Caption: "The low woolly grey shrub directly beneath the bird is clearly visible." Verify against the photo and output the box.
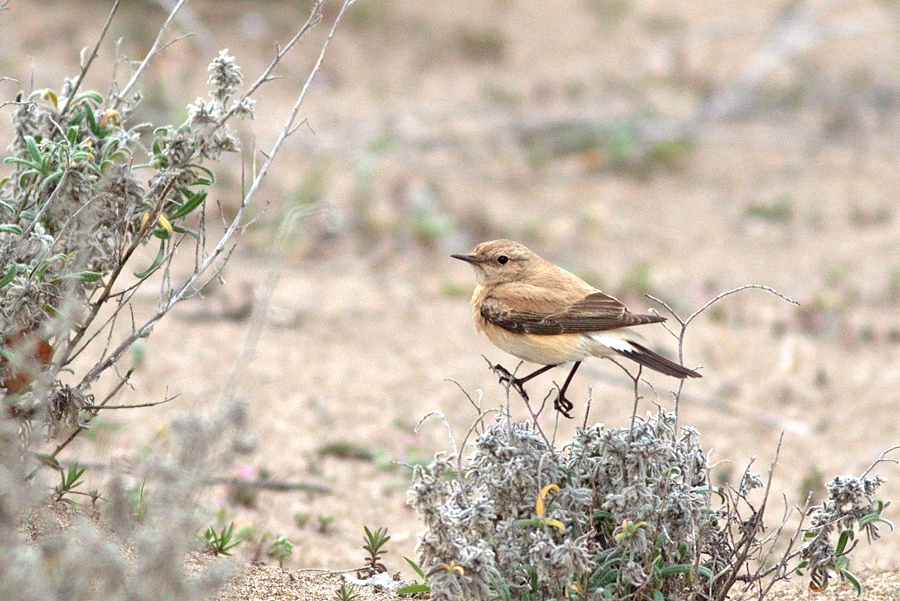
[410,290,893,601]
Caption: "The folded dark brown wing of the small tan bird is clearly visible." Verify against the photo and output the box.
[481,292,666,334]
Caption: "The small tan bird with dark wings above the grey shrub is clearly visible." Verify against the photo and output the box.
[451,240,701,417]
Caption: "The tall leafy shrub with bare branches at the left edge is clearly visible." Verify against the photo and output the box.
[0,0,350,601]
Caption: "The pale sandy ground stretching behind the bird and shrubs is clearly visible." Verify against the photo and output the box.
[0,0,900,598]
